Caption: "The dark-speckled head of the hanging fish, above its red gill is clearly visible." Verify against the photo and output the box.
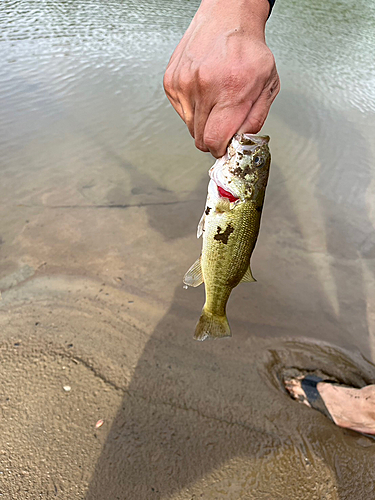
[210,134,271,202]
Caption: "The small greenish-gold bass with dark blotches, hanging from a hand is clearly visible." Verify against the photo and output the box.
[183,134,271,341]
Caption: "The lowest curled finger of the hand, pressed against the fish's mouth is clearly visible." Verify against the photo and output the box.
[203,102,251,158]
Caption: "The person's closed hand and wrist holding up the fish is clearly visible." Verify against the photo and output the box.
[164,0,280,158]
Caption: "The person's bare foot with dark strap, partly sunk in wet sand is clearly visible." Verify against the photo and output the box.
[284,375,375,435]
